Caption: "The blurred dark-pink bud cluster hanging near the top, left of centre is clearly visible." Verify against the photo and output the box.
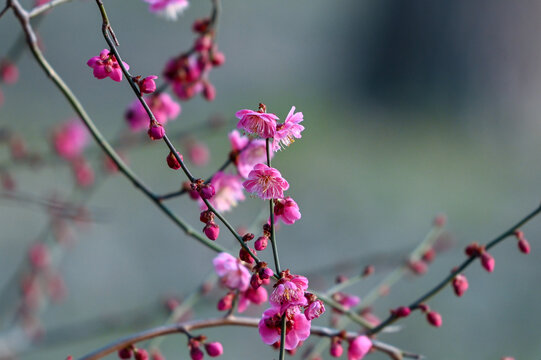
[163,18,225,101]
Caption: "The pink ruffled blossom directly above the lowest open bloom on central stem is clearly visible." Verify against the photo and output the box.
[270,270,308,313]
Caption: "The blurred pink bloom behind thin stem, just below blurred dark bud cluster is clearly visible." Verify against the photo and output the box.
[125,93,181,131]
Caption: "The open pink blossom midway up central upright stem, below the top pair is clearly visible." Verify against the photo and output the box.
[242,164,289,200]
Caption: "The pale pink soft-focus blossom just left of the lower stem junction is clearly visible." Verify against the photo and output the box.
[212,252,250,291]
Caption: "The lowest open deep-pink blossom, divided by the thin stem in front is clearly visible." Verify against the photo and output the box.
[258,306,311,350]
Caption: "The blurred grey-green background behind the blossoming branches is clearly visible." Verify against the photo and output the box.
[0,0,541,360]
